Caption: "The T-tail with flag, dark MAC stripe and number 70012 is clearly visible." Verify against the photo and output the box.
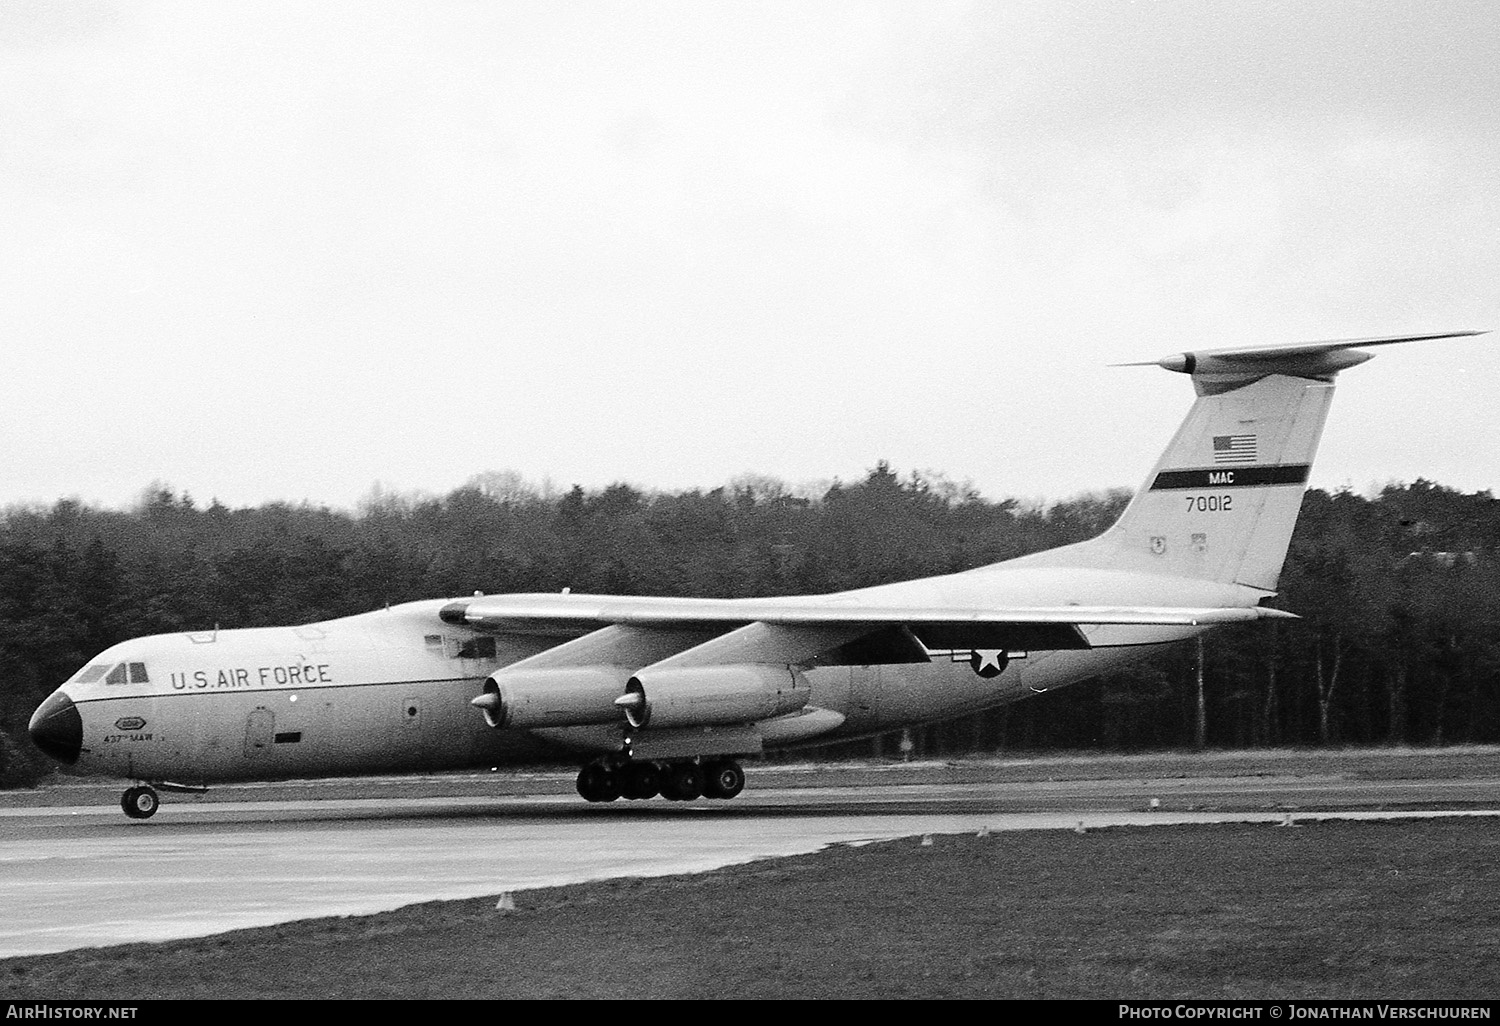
[1025,332,1484,593]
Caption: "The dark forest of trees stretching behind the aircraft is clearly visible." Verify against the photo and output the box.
[0,462,1500,786]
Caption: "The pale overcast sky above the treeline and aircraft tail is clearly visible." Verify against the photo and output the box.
[0,0,1500,509]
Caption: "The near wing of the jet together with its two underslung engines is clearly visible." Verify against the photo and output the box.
[441,594,1290,744]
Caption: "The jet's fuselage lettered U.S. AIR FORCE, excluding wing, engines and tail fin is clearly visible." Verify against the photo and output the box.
[32,561,1263,785]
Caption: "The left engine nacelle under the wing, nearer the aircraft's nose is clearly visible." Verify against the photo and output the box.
[473,666,630,728]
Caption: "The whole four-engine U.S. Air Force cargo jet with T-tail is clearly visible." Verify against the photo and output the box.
[30,332,1479,819]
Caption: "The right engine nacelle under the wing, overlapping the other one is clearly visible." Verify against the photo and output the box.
[617,663,812,728]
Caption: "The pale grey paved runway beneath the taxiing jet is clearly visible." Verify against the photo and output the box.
[0,753,1500,957]
